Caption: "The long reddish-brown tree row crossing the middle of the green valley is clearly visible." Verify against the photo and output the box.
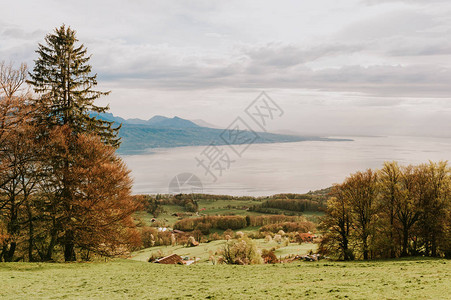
[174,215,305,234]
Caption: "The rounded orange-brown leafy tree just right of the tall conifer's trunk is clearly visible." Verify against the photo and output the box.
[63,134,138,256]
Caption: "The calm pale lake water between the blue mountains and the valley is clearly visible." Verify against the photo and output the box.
[123,137,451,196]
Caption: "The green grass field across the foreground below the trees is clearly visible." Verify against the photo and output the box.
[0,259,451,299]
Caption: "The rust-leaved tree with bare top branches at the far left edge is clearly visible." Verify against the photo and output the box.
[0,63,40,261]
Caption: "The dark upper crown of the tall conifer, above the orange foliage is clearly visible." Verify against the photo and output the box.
[28,25,120,147]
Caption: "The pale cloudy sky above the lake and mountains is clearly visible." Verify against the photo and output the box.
[0,0,451,137]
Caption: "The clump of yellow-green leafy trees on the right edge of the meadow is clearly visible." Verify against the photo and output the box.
[320,161,451,259]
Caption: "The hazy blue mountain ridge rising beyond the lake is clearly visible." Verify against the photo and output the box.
[88,113,354,154]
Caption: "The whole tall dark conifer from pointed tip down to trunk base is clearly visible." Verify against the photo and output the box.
[28,25,120,261]
